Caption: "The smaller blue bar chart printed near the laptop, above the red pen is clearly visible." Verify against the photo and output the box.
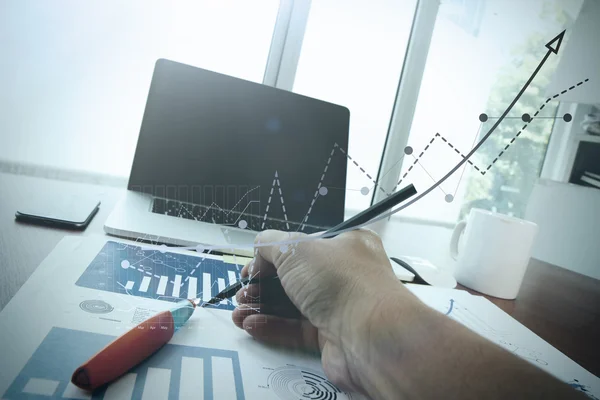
[76,241,240,310]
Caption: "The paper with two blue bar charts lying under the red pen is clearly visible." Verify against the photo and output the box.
[0,236,362,400]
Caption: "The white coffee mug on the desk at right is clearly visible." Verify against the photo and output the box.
[450,208,538,299]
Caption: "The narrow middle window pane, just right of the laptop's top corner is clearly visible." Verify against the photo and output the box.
[293,0,416,212]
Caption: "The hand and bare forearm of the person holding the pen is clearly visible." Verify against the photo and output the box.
[233,230,585,400]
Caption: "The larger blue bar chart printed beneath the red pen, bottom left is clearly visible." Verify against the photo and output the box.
[0,328,245,400]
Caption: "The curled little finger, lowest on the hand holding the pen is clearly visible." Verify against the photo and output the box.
[237,313,320,351]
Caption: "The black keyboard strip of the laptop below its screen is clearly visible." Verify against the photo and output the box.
[152,197,327,233]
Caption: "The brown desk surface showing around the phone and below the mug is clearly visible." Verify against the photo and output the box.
[0,173,600,376]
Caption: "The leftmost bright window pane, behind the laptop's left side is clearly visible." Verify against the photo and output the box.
[0,0,279,177]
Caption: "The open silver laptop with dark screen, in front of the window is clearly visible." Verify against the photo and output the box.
[104,59,350,254]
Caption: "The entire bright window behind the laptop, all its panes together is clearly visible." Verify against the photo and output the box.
[0,0,583,223]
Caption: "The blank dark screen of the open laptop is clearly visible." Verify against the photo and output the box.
[128,60,349,230]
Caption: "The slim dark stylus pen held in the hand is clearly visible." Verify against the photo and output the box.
[201,184,417,307]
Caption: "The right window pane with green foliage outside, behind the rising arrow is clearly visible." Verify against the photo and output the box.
[394,0,582,223]
